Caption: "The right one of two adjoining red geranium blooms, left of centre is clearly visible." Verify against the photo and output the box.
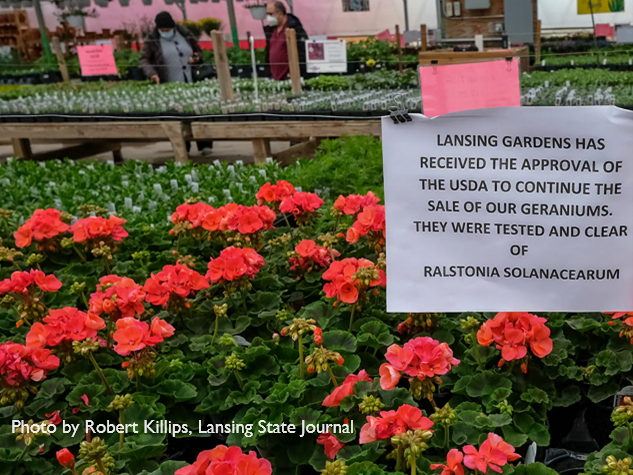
[143,264,209,307]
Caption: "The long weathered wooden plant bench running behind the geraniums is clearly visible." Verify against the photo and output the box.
[0,119,381,164]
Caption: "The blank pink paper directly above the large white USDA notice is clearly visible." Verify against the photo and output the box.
[420,59,521,117]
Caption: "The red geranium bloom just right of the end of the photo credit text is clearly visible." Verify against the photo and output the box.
[359,404,433,444]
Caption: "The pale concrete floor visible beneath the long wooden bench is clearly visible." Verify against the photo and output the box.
[0,141,290,165]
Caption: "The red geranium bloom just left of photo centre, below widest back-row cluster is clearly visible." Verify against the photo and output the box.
[206,246,264,283]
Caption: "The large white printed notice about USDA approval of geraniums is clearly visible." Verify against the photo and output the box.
[382,106,633,312]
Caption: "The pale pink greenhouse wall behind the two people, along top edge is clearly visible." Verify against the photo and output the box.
[19,0,437,38]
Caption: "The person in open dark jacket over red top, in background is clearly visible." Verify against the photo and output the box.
[264,1,308,81]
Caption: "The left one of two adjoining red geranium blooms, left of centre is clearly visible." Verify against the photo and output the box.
[89,275,146,320]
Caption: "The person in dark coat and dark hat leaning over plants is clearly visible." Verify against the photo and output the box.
[140,12,213,154]
